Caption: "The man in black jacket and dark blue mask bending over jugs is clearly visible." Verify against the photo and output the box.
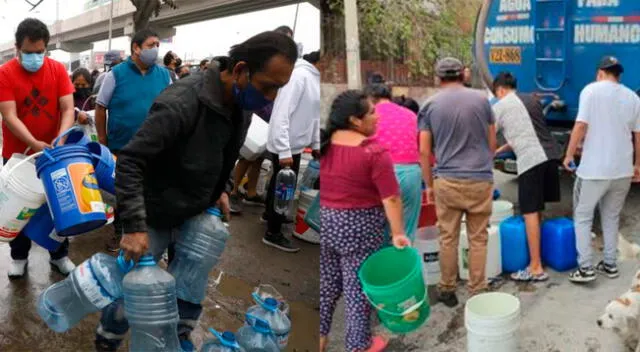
[95,32,298,351]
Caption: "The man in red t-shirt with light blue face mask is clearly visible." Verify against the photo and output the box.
[0,18,75,278]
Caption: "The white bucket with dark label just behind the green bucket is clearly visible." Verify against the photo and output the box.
[414,226,440,285]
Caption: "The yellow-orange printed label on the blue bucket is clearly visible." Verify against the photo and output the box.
[67,163,104,214]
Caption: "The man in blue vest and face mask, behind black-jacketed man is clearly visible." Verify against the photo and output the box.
[95,29,171,252]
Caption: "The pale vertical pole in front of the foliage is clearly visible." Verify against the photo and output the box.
[344,0,362,89]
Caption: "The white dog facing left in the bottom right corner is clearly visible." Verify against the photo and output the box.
[597,286,640,352]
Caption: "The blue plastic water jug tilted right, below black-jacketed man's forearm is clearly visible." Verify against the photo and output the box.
[168,208,229,304]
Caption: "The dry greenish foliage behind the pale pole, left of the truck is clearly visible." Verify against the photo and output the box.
[323,0,480,75]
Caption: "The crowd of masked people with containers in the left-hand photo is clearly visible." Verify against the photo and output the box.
[0,18,320,351]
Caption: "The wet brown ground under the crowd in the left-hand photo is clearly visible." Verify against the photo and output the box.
[0,199,319,352]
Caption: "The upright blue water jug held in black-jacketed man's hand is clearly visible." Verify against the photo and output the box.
[120,255,182,352]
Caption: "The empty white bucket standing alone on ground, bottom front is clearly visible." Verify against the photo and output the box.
[464,292,520,352]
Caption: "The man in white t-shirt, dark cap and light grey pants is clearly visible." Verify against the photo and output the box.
[563,56,640,283]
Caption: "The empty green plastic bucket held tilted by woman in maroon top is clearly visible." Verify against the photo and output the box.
[358,247,430,334]
